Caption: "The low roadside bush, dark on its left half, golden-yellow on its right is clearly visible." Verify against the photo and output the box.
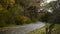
[15,16,31,25]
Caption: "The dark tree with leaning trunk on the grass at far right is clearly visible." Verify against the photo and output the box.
[41,1,60,34]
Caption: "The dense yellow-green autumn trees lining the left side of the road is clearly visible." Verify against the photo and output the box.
[0,0,39,27]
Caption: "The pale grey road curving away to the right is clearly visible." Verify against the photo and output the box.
[0,22,45,34]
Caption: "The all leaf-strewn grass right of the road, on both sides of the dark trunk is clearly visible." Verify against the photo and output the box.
[27,23,60,34]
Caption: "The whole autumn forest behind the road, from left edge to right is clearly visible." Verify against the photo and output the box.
[0,0,60,27]
